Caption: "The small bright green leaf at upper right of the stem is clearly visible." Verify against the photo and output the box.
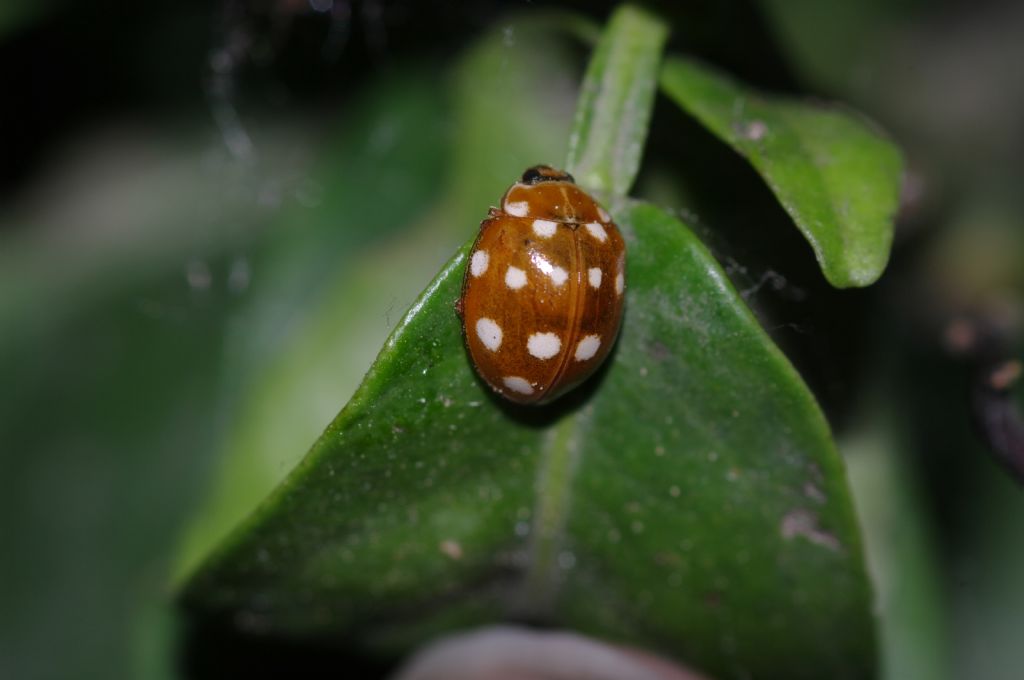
[660,57,902,288]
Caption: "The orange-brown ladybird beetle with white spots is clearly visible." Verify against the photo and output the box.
[456,165,626,403]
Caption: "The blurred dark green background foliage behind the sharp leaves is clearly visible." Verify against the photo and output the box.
[0,0,1024,679]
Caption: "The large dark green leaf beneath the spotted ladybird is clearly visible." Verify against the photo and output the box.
[184,204,874,678]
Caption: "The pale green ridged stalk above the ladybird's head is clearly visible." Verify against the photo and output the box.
[565,5,669,198]
